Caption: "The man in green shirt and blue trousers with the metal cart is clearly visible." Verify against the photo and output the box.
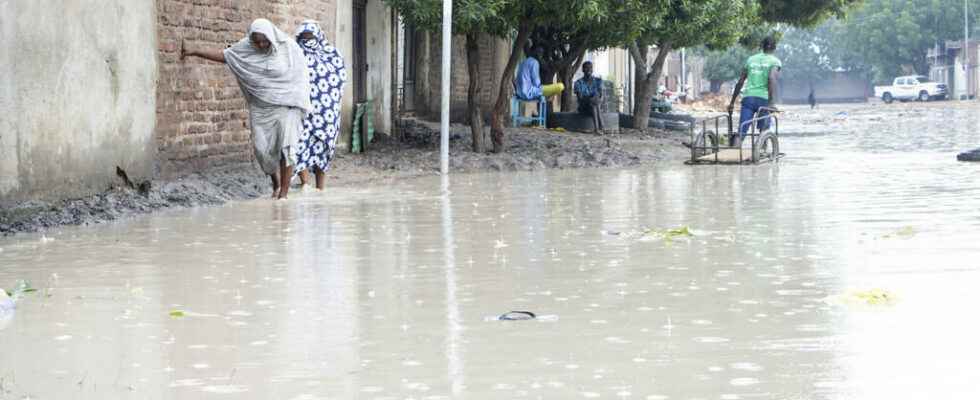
[728,37,783,143]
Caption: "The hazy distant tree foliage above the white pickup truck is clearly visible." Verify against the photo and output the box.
[838,0,980,82]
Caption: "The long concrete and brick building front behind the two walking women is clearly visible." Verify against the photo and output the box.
[0,0,399,202]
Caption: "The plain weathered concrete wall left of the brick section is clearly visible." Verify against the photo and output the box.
[0,0,157,205]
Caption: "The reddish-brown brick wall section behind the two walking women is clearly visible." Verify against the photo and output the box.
[156,0,337,175]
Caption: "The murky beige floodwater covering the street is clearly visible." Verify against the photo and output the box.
[0,103,980,400]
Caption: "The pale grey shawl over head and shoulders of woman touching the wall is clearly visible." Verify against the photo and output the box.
[225,19,313,113]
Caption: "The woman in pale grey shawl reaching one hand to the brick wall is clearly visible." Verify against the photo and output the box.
[181,19,313,199]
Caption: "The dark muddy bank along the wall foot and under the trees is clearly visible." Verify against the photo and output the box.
[0,120,687,236]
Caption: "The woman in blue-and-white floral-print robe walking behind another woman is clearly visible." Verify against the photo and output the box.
[296,21,347,190]
